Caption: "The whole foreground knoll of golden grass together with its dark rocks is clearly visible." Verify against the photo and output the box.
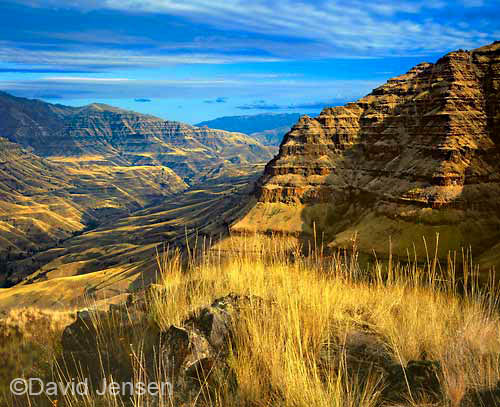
[0,236,500,407]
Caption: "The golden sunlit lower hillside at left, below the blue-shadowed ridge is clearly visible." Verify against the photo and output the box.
[0,138,187,281]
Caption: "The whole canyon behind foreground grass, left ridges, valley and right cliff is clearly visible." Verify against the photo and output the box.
[0,43,500,308]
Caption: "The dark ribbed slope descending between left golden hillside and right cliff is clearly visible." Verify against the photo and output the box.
[0,165,263,309]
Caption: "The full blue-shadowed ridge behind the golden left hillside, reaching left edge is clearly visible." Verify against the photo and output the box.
[0,92,275,183]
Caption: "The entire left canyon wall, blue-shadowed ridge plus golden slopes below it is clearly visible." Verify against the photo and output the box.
[0,92,276,272]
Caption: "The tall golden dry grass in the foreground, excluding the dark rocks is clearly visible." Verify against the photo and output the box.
[0,236,500,407]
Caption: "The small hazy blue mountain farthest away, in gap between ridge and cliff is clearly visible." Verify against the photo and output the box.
[196,113,310,146]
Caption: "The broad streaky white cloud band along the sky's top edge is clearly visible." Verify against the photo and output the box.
[10,0,491,55]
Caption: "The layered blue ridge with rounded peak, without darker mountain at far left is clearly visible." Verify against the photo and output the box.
[45,104,272,175]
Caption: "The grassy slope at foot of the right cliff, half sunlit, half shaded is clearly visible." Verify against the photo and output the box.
[231,202,500,278]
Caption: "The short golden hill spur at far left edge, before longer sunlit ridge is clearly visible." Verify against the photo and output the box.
[0,137,78,284]
